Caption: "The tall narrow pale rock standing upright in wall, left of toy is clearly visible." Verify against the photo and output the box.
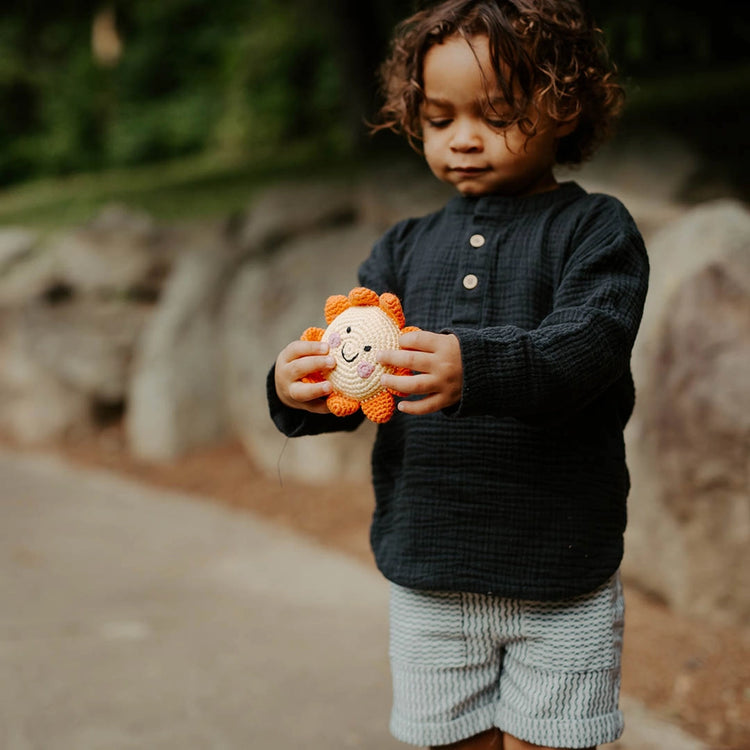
[126,232,238,461]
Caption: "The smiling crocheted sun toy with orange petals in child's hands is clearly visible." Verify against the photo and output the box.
[301,287,419,424]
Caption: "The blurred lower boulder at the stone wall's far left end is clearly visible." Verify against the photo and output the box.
[0,296,150,444]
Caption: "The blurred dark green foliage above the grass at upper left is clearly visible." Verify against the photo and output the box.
[0,0,362,184]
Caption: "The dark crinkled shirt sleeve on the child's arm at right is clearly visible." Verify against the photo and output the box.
[447,217,648,422]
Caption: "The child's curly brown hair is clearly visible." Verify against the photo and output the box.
[372,0,624,165]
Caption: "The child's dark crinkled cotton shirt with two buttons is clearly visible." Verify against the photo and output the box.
[269,182,648,600]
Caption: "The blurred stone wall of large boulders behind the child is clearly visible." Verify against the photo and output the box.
[0,144,750,624]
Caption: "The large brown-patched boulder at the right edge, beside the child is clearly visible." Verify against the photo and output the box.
[623,201,750,624]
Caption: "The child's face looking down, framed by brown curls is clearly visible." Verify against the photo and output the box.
[421,36,575,196]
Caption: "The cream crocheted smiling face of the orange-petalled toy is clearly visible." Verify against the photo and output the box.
[322,306,399,401]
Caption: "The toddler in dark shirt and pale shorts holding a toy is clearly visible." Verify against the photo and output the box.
[268,0,648,750]
